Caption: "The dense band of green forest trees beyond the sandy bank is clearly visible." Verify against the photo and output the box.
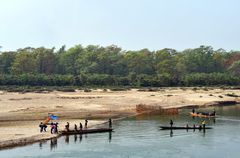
[0,45,240,87]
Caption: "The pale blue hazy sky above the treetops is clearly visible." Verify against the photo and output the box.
[0,0,240,51]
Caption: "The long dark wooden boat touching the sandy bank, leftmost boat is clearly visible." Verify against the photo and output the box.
[60,128,113,135]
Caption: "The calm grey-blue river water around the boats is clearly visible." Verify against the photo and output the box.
[0,105,240,158]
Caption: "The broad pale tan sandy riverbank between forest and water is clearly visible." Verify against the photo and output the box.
[0,88,240,148]
